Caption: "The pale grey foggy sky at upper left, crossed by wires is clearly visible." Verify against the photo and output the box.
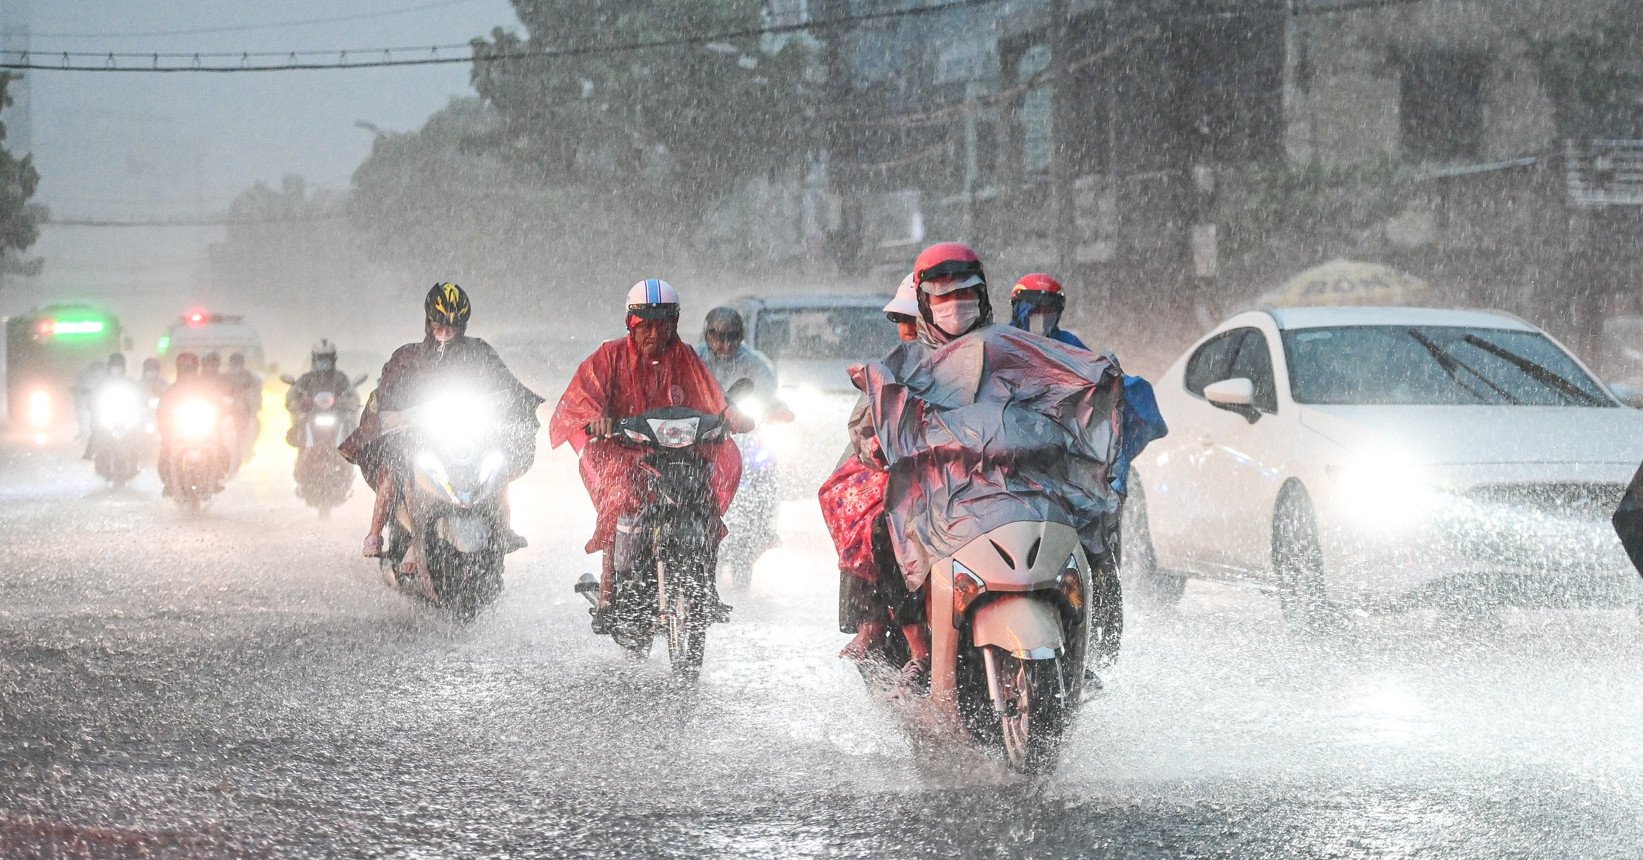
[0,0,518,333]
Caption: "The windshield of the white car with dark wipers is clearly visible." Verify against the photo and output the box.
[1283,326,1615,406]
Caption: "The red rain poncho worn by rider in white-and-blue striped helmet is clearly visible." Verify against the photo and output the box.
[547,337,741,553]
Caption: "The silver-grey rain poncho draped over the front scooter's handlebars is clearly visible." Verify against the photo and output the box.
[851,326,1124,589]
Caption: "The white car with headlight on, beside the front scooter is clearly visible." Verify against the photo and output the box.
[1124,307,1643,630]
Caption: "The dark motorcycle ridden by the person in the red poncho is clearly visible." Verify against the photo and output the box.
[577,380,751,681]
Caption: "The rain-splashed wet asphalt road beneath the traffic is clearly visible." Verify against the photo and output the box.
[0,444,1643,858]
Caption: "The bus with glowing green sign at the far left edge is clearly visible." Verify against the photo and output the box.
[5,304,123,434]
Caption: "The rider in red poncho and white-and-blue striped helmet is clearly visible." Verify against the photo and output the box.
[547,278,751,618]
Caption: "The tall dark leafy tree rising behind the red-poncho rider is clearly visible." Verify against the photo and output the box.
[473,0,808,250]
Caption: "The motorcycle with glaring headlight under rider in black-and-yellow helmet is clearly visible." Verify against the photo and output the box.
[381,393,508,622]
